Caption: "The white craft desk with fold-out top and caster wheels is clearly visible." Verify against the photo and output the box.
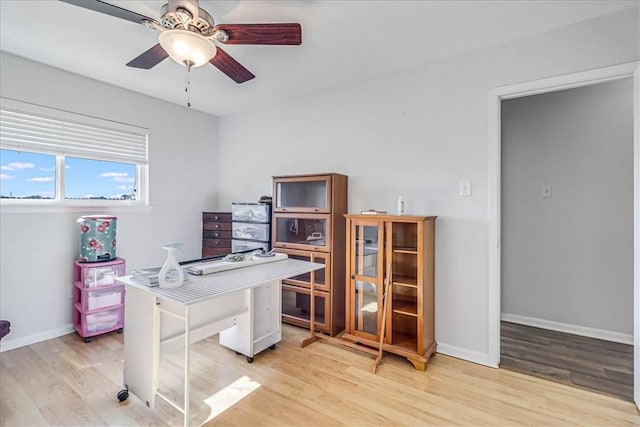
[117,259,324,426]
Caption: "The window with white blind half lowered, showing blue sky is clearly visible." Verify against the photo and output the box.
[0,98,148,206]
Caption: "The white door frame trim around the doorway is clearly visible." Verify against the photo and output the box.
[487,61,640,408]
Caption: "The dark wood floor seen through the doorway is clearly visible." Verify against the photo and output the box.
[500,322,633,401]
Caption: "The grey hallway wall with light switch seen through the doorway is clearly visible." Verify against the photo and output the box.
[501,78,633,341]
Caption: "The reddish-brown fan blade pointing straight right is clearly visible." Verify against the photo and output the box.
[213,24,302,45]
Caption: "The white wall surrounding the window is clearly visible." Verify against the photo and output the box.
[0,52,218,350]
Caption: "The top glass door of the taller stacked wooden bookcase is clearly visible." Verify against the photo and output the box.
[273,175,331,213]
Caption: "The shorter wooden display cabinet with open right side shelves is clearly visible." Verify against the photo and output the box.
[343,215,436,370]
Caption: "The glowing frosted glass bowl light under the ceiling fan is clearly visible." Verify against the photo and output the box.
[159,30,216,68]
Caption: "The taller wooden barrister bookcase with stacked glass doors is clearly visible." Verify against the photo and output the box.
[272,173,347,336]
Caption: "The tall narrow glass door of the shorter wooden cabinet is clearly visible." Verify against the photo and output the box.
[348,220,384,339]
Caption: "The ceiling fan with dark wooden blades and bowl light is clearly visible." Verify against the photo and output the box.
[61,0,302,83]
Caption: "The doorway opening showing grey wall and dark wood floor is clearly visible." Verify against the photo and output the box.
[500,78,633,401]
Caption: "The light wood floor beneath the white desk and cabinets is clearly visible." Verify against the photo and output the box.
[0,325,640,427]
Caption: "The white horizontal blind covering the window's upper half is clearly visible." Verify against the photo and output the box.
[0,98,148,165]
